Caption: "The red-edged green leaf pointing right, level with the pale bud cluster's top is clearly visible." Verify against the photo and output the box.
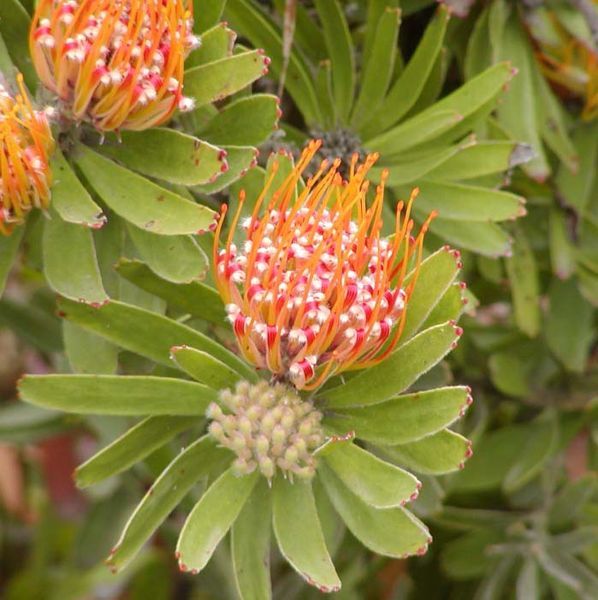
[328,386,471,446]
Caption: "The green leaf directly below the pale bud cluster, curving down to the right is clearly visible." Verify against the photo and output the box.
[272,475,341,592]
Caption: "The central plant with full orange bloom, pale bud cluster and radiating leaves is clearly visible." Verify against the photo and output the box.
[20,142,471,598]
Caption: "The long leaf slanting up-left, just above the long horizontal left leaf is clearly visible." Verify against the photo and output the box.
[59,300,253,377]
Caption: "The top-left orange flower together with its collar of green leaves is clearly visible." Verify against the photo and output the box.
[0,0,279,318]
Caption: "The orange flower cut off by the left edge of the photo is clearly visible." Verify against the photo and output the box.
[0,75,54,235]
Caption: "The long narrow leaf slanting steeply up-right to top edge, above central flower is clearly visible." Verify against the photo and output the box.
[362,7,449,139]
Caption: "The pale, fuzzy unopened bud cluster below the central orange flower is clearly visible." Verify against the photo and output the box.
[207,381,324,479]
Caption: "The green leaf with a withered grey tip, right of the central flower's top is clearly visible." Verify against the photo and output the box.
[426,141,533,181]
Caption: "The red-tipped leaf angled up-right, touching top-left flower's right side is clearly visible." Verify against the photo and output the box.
[185,50,269,106]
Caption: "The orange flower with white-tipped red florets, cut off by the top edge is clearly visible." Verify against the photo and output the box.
[29,0,199,131]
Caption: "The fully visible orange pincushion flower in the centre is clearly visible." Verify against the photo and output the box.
[214,141,434,389]
